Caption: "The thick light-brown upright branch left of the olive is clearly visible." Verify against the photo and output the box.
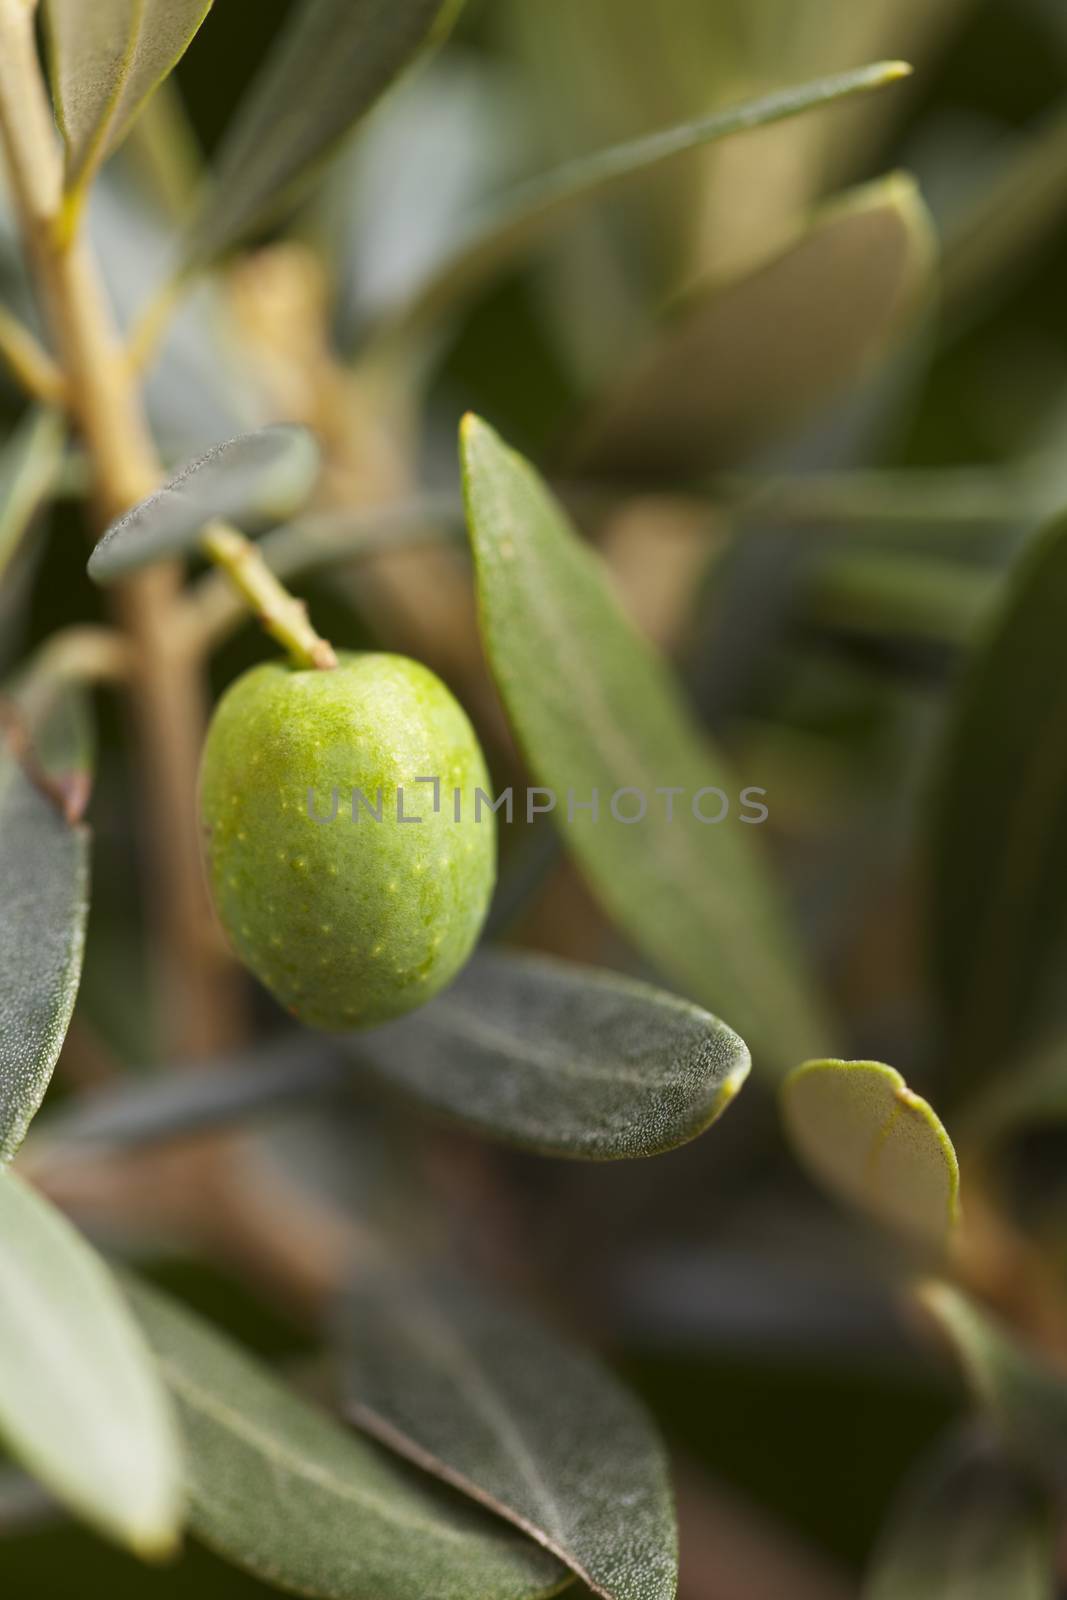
[0,0,230,1054]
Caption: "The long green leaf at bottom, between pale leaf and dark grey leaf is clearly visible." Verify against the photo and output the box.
[130,1285,563,1600]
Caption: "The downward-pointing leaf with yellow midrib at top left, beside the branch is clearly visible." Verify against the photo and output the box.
[45,0,211,209]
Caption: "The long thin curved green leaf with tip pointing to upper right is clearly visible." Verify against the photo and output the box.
[379,61,912,336]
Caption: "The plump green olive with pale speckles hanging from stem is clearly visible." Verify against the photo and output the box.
[200,654,496,1032]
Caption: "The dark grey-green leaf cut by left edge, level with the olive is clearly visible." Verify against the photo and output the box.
[0,723,90,1162]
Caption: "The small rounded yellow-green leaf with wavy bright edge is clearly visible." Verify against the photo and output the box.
[782,1061,960,1245]
